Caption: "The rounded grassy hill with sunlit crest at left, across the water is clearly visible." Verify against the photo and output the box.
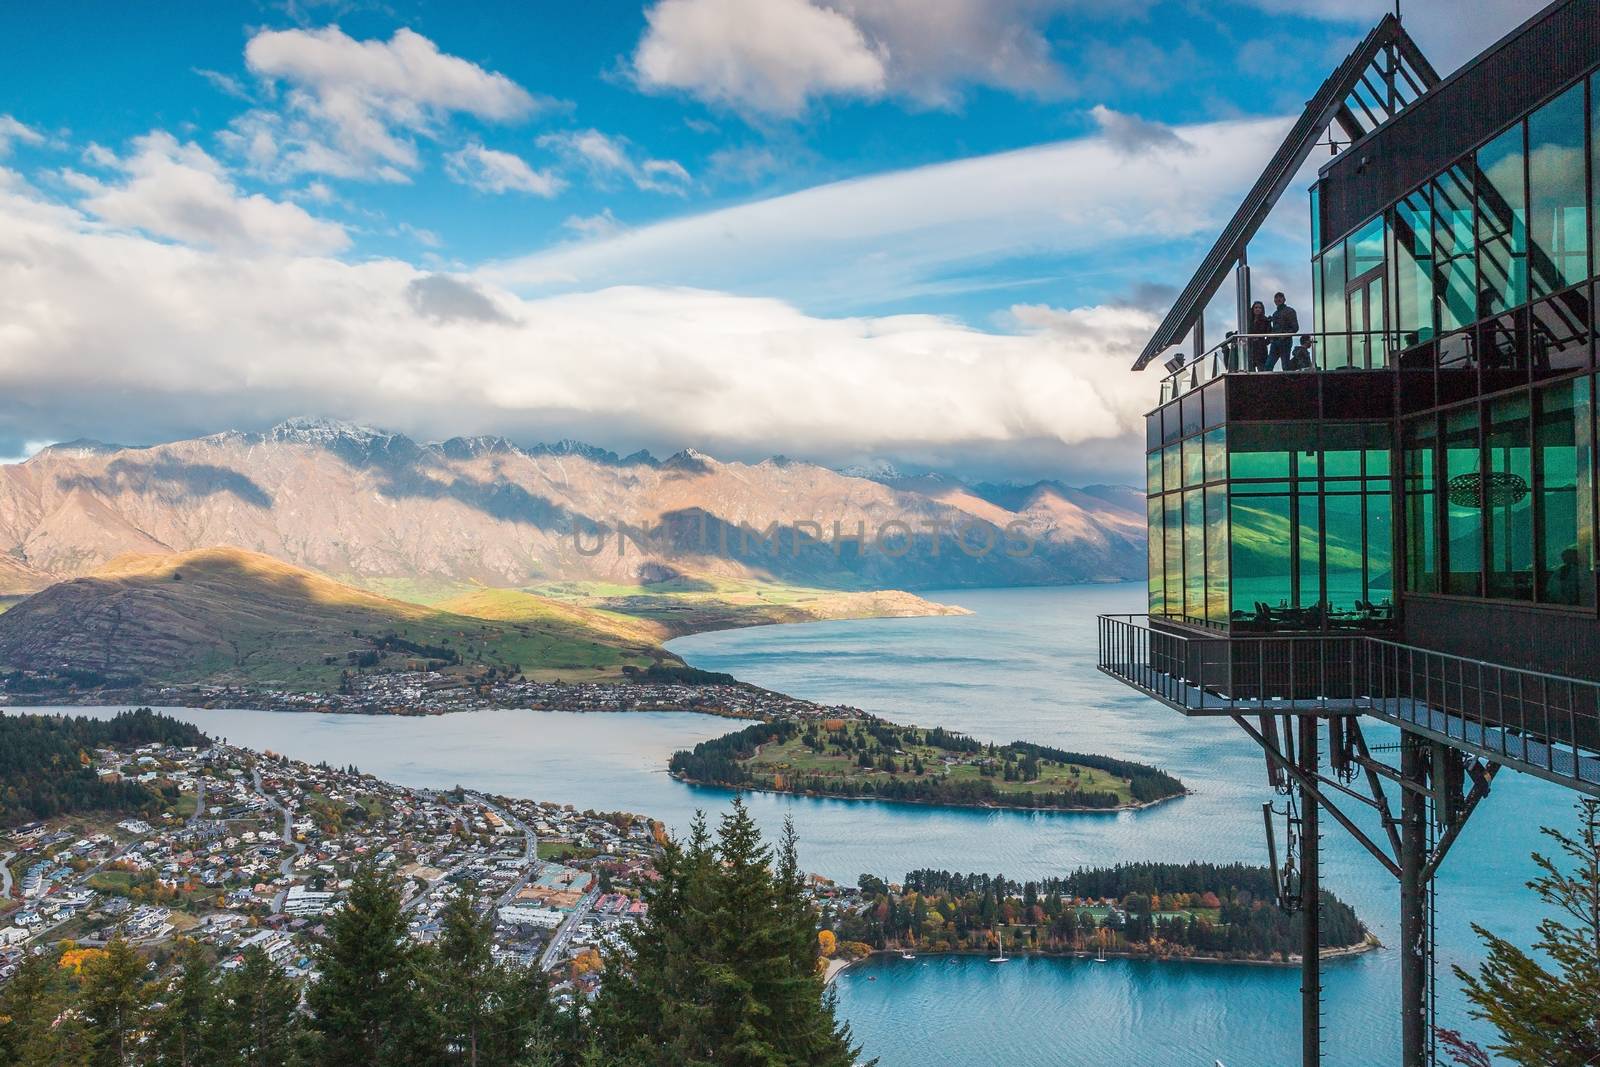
[0,549,678,689]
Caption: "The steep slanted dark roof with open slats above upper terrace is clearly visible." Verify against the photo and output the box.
[1133,14,1438,371]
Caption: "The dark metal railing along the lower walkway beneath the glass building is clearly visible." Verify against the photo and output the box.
[1099,614,1600,797]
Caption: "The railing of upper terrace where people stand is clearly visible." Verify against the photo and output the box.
[1162,330,1400,403]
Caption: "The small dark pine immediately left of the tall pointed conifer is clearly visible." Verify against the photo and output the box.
[203,947,299,1067]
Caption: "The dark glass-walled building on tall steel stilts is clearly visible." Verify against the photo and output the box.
[1099,0,1600,1067]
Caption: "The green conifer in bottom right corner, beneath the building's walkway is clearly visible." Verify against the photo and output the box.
[1451,800,1600,1067]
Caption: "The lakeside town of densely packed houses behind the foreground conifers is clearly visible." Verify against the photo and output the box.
[0,744,664,1000]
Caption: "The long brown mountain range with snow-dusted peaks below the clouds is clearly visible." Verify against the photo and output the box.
[0,418,1144,601]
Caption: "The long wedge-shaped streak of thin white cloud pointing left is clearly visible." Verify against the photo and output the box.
[485,118,1304,310]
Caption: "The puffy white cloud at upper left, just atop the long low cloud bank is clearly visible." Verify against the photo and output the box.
[64,131,350,253]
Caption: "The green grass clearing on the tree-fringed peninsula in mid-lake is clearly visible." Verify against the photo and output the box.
[749,723,1133,805]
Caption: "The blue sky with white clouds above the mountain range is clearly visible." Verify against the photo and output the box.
[0,0,1536,477]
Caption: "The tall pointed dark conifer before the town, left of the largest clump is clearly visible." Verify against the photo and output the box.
[306,861,440,1067]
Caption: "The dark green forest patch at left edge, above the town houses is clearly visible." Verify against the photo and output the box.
[0,707,206,825]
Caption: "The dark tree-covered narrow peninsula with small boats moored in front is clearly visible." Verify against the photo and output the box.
[834,862,1366,960]
